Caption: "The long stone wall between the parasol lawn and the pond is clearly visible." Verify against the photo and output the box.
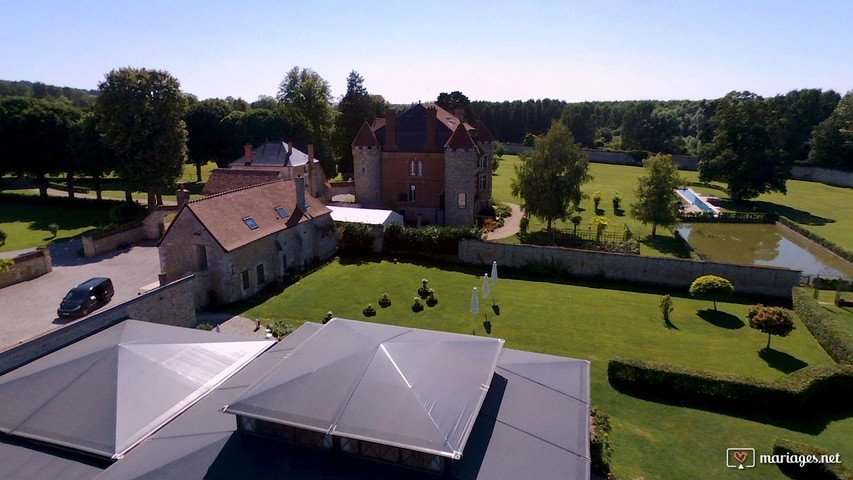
[459,240,802,298]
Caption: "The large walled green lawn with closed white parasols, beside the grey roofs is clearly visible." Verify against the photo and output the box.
[230,260,853,480]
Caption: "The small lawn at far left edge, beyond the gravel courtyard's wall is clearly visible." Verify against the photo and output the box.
[0,202,109,252]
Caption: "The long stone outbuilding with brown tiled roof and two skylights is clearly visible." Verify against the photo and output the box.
[158,177,337,306]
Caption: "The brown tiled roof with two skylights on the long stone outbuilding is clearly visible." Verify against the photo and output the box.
[181,180,331,251]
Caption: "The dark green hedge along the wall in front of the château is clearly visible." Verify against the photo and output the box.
[383,223,482,255]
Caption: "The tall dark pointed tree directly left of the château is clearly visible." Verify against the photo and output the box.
[332,70,387,176]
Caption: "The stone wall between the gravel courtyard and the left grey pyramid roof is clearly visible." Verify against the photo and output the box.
[0,276,196,374]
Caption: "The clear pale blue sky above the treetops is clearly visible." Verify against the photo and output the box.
[0,0,853,103]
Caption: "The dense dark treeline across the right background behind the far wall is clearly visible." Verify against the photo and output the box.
[470,89,853,169]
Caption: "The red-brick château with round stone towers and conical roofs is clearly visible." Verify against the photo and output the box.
[352,104,496,225]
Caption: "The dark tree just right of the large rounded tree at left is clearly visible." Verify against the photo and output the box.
[184,98,231,177]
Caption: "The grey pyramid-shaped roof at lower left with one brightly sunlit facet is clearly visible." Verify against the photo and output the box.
[0,320,270,458]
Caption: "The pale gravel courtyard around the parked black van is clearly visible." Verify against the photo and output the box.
[0,239,160,350]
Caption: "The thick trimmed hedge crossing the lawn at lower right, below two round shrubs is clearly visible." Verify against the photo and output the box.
[607,358,853,418]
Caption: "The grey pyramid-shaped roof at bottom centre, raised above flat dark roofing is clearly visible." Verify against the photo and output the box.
[225,318,504,459]
